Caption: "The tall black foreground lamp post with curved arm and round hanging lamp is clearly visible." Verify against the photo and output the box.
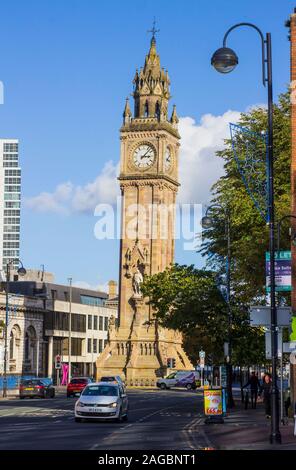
[211,23,281,443]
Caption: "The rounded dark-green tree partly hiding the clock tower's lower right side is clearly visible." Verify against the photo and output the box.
[141,264,262,365]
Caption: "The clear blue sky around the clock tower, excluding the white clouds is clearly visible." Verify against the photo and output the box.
[0,0,295,285]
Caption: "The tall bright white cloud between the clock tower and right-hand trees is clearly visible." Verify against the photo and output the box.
[178,110,240,204]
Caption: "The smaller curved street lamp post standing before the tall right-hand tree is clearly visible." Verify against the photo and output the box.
[201,204,234,408]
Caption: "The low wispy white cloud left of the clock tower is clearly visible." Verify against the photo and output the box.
[24,161,119,214]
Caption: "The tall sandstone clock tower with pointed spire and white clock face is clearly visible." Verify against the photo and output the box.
[97,30,192,385]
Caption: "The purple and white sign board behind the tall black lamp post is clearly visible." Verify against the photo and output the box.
[265,251,292,292]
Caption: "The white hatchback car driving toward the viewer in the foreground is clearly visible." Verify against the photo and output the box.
[75,382,128,422]
